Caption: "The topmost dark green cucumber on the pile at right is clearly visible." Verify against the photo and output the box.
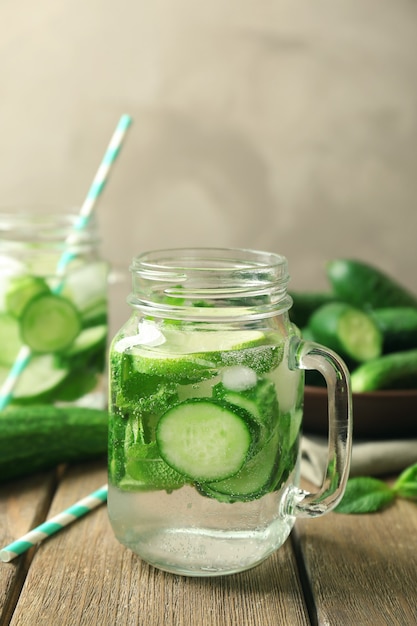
[326,259,417,309]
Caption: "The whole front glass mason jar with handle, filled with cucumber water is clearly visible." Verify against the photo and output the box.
[108,248,352,576]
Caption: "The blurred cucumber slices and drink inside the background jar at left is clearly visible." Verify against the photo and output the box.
[0,260,107,406]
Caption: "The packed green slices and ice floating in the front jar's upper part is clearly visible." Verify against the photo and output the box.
[109,321,302,494]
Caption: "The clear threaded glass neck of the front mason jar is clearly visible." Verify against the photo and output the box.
[128,248,291,321]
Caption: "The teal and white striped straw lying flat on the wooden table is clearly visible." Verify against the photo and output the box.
[0,485,107,563]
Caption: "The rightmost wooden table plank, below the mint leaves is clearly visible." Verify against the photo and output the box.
[293,490,417,626]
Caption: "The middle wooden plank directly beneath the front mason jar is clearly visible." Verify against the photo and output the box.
[11,464,310,626]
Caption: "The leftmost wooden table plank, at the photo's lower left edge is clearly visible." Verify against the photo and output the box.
[0,472,56,624]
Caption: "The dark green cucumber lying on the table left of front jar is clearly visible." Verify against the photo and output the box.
[0,405,108,483]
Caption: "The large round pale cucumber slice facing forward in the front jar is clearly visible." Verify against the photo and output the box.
[156,398,258,482]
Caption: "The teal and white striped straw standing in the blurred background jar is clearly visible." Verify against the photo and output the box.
[0,115,132,411]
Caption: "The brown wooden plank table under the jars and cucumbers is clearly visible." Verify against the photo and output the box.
[0,462,417,626]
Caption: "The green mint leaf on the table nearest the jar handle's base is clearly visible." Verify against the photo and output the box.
[334,476,396,513]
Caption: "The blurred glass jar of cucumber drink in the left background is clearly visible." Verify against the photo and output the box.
[0,207,108,408]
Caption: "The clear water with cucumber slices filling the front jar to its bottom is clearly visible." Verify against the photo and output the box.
[108,320,303,573]
